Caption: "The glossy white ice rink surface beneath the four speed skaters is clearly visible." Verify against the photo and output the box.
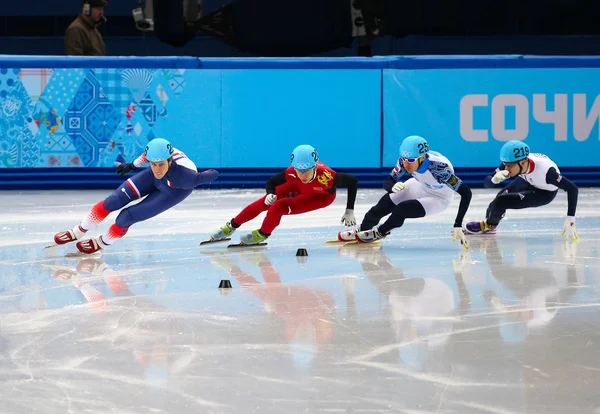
[0,189,600,414]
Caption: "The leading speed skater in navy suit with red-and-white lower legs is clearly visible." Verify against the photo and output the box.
[54,138,219,254]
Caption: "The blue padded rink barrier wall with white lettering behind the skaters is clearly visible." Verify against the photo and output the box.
[0,55,600,189]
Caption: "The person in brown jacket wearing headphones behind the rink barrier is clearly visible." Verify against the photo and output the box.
[65,0,106,56]
